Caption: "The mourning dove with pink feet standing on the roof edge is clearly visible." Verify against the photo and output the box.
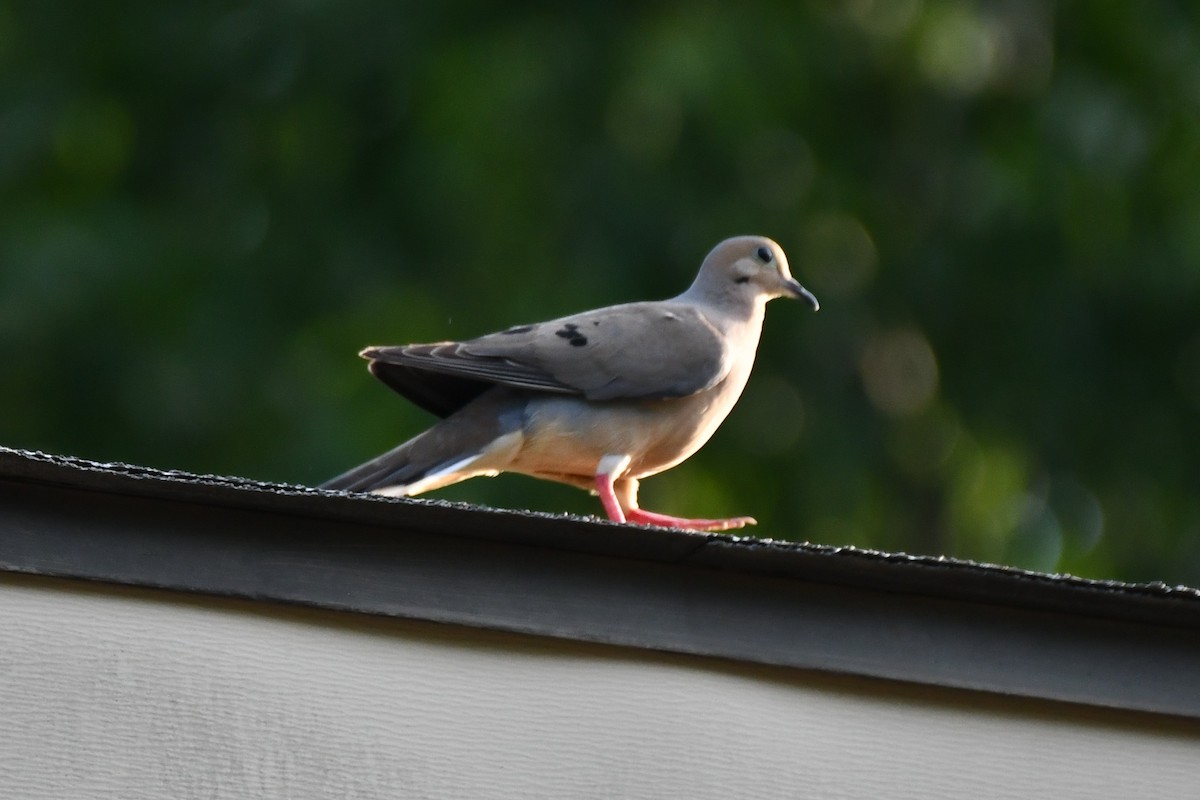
[323,236,818,530]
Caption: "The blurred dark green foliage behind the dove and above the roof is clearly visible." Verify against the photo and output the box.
[0,0,1200,584]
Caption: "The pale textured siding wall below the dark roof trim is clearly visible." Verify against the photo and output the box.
[0,577,1200,800]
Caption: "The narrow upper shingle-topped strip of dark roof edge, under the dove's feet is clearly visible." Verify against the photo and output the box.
[0,446,1200,627]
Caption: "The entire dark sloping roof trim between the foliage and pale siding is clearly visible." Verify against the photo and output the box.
[0,449,1200,718]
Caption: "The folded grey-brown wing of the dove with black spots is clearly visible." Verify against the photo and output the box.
[362,302,730,401]
